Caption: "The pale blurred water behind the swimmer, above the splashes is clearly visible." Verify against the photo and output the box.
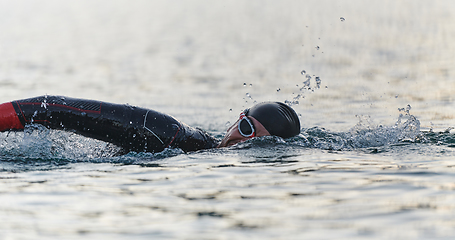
[0,0,455,132]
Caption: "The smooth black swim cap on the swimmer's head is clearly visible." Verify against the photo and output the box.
[245,102,300,138]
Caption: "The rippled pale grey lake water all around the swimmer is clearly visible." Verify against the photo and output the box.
[0,0,455,239]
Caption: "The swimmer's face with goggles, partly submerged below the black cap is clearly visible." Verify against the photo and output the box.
[218,117,270,147]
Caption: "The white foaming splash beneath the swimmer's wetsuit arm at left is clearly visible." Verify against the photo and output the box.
[0,124,189,172]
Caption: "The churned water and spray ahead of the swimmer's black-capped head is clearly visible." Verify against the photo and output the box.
[226,106,430,153]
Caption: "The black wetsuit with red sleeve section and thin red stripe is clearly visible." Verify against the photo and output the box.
[0,96,218,152]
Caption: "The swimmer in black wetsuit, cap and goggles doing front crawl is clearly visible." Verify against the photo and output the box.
[0,96,300,153]
